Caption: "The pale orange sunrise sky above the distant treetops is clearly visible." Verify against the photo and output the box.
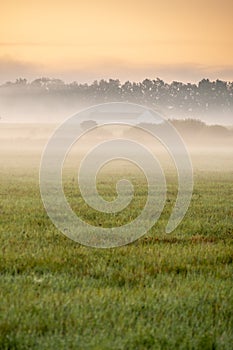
[0,0,233,83]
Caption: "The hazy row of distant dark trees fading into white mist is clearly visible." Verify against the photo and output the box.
[0,77,233,118]
